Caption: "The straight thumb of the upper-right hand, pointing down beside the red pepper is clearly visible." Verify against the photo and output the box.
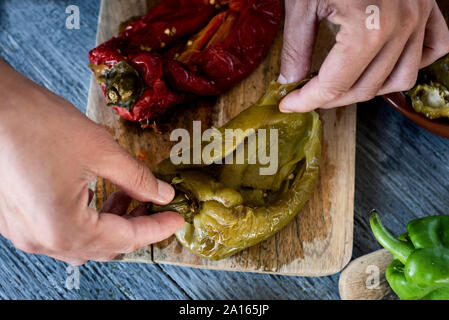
[278,0,318,84]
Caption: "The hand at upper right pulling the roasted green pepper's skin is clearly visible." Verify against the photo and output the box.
[278,0,449,112]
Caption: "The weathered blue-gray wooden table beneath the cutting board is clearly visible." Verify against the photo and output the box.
[0,0,449,299]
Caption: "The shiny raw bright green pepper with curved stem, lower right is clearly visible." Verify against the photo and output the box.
[370,212,449,300]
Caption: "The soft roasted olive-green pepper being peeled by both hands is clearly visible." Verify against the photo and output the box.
[147,83,321,260]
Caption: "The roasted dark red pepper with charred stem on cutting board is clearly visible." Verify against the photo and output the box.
[89,0,281,121]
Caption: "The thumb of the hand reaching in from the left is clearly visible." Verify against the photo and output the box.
[93,133,175,204]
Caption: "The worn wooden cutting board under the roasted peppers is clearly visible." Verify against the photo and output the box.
[86,0,356,276]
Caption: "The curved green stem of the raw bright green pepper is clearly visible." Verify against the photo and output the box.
[369,210,415,264]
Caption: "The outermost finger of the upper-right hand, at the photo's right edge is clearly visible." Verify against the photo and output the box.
[420,3,449,68]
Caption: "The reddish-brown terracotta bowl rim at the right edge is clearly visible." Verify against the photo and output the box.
[383,92,449,139]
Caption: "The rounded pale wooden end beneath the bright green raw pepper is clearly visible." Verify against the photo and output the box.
[338,249,397,300]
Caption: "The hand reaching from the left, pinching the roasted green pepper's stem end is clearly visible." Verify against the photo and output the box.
[0,60,184,264]
